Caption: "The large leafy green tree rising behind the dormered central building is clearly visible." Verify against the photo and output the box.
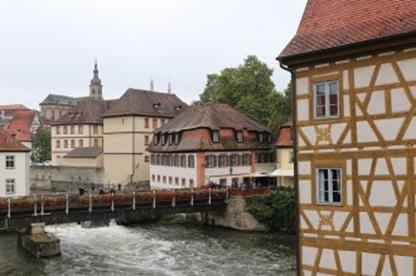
[200,56,291,133]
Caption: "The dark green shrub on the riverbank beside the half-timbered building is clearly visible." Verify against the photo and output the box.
[246,188,296,233]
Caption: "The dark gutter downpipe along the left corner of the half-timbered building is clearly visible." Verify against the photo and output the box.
[277,59,302,275]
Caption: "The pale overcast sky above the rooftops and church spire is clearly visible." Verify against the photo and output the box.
[0,0,306,108]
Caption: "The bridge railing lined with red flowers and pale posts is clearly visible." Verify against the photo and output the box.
[0,189,229,218]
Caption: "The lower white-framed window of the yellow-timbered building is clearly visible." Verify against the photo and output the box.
[317,168,342,205]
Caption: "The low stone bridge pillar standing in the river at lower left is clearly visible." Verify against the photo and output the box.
[17,223,61,258]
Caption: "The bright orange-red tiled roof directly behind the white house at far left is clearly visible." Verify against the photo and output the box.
[6,110,36,142]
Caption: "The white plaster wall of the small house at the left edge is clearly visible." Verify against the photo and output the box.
[0,152,30,196]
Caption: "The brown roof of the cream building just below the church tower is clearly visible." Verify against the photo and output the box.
[51,98,117,125]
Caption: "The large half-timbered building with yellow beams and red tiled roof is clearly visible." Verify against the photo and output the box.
[279,0,416,275]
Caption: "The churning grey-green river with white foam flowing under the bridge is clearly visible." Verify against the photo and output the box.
[0,224,296,276]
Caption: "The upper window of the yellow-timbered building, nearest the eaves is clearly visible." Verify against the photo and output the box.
[314,80,339,119]
